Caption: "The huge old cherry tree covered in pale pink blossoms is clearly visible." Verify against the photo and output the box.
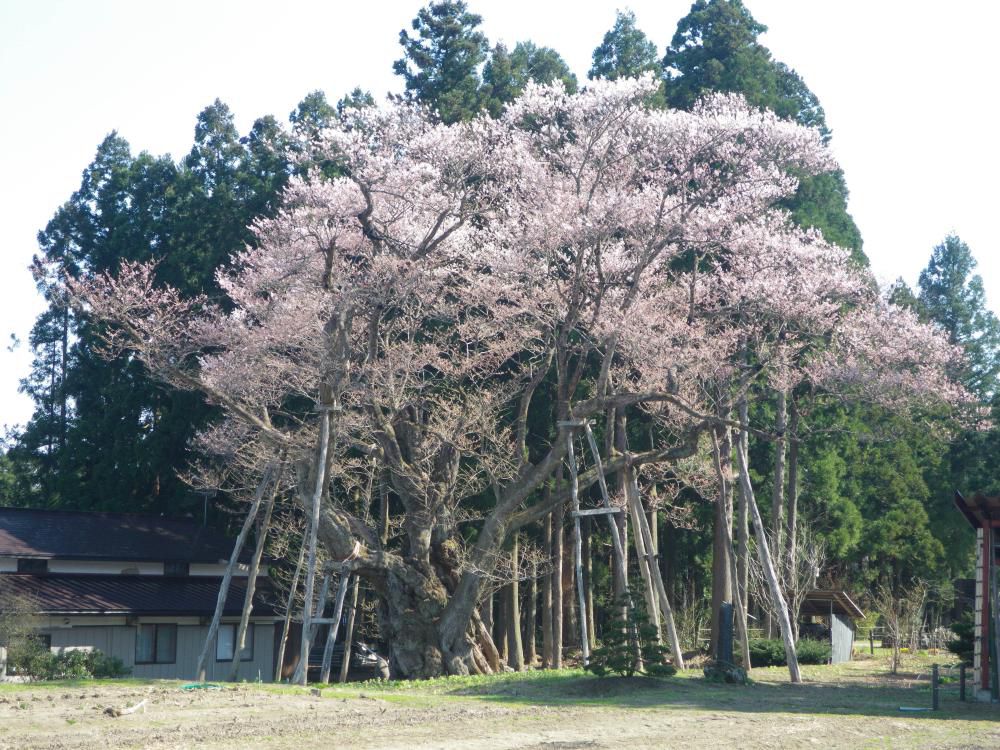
[73,77,957,677]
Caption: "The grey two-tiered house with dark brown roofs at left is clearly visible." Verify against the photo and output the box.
[0,508,279,681]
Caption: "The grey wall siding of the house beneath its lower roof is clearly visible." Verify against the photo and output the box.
[42,621,274,682]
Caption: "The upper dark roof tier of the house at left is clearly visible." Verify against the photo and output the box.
[0,508,246,563]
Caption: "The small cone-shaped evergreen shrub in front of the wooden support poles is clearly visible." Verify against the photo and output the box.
[586,599,677,677]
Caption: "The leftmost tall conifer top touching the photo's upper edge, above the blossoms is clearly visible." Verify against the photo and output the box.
[392,0,488,123]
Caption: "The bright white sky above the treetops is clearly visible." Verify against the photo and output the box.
[0,0,1000,432]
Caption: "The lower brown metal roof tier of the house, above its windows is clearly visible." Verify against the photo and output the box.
[0,573,274,617]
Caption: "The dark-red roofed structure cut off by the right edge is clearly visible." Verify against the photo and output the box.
[955,492,1000,700]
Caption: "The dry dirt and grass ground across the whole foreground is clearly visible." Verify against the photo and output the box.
[0,665,1000,750]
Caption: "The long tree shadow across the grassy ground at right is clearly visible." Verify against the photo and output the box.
[445,673,1000,721]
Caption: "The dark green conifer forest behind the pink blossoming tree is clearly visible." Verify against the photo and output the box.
[0,0,1000,656]
